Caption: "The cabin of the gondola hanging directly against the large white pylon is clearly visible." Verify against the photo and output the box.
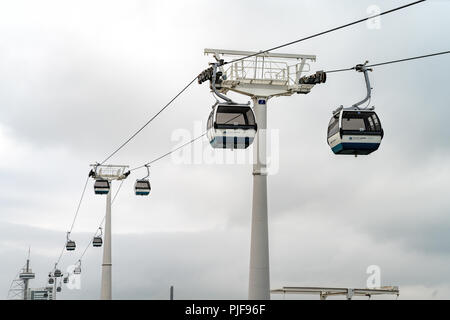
[206,103,257,149]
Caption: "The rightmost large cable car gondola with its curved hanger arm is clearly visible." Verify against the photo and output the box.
[327,62,384,156]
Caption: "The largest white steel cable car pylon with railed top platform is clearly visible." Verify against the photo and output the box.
[204,49,316,300]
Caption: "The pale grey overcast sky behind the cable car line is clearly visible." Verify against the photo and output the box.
[0,0,450,299]
